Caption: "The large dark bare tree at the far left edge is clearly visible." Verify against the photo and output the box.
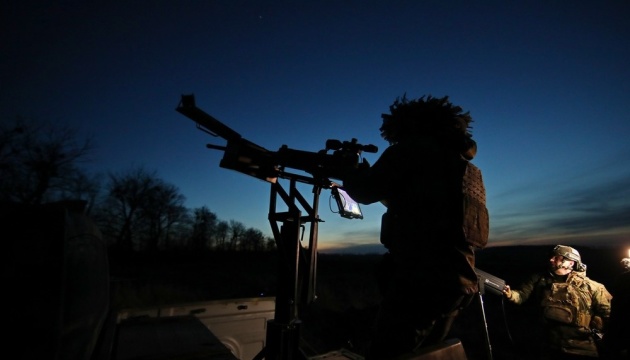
[0,117,99,204]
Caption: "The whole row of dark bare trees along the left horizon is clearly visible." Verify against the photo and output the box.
[0,117,275,252]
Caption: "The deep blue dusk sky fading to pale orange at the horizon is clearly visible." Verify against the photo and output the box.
[0,0,630,250]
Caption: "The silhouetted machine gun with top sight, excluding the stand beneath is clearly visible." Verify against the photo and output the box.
[176,95,378,183]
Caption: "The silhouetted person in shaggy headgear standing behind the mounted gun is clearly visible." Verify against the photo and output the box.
[343,96,489,360]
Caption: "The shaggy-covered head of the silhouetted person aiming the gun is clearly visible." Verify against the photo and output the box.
[380,95,477,160]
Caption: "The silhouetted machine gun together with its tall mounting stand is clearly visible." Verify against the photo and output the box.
[176,95,378,360]
